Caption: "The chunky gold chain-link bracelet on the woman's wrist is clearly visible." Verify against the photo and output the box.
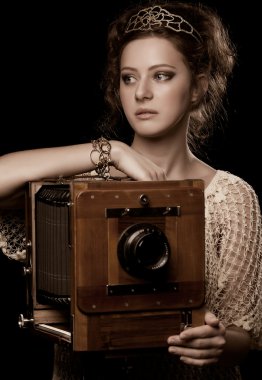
[90,137,112,180]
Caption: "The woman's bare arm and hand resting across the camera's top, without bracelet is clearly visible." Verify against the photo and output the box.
[0,140,165,198]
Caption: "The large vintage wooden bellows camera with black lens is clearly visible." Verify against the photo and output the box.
[19,178,205,351]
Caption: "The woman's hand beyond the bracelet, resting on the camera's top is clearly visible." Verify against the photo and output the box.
[110,140,166,181]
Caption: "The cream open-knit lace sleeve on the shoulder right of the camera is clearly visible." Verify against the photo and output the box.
[206,174,262,344]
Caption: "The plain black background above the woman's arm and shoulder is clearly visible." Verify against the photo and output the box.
[0,0,262,205]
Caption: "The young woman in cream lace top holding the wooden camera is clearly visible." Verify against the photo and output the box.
[0,2,262,380]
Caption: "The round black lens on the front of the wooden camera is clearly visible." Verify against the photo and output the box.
[118,223,170,277]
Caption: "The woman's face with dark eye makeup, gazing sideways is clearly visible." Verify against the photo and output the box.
[120,37,196,137]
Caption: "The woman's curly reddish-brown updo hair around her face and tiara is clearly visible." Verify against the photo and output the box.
[97,0,236,151]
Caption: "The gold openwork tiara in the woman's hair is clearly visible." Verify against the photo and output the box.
[125,5,202,42]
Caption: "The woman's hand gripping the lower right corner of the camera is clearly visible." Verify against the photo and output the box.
[167,312,226,366]
